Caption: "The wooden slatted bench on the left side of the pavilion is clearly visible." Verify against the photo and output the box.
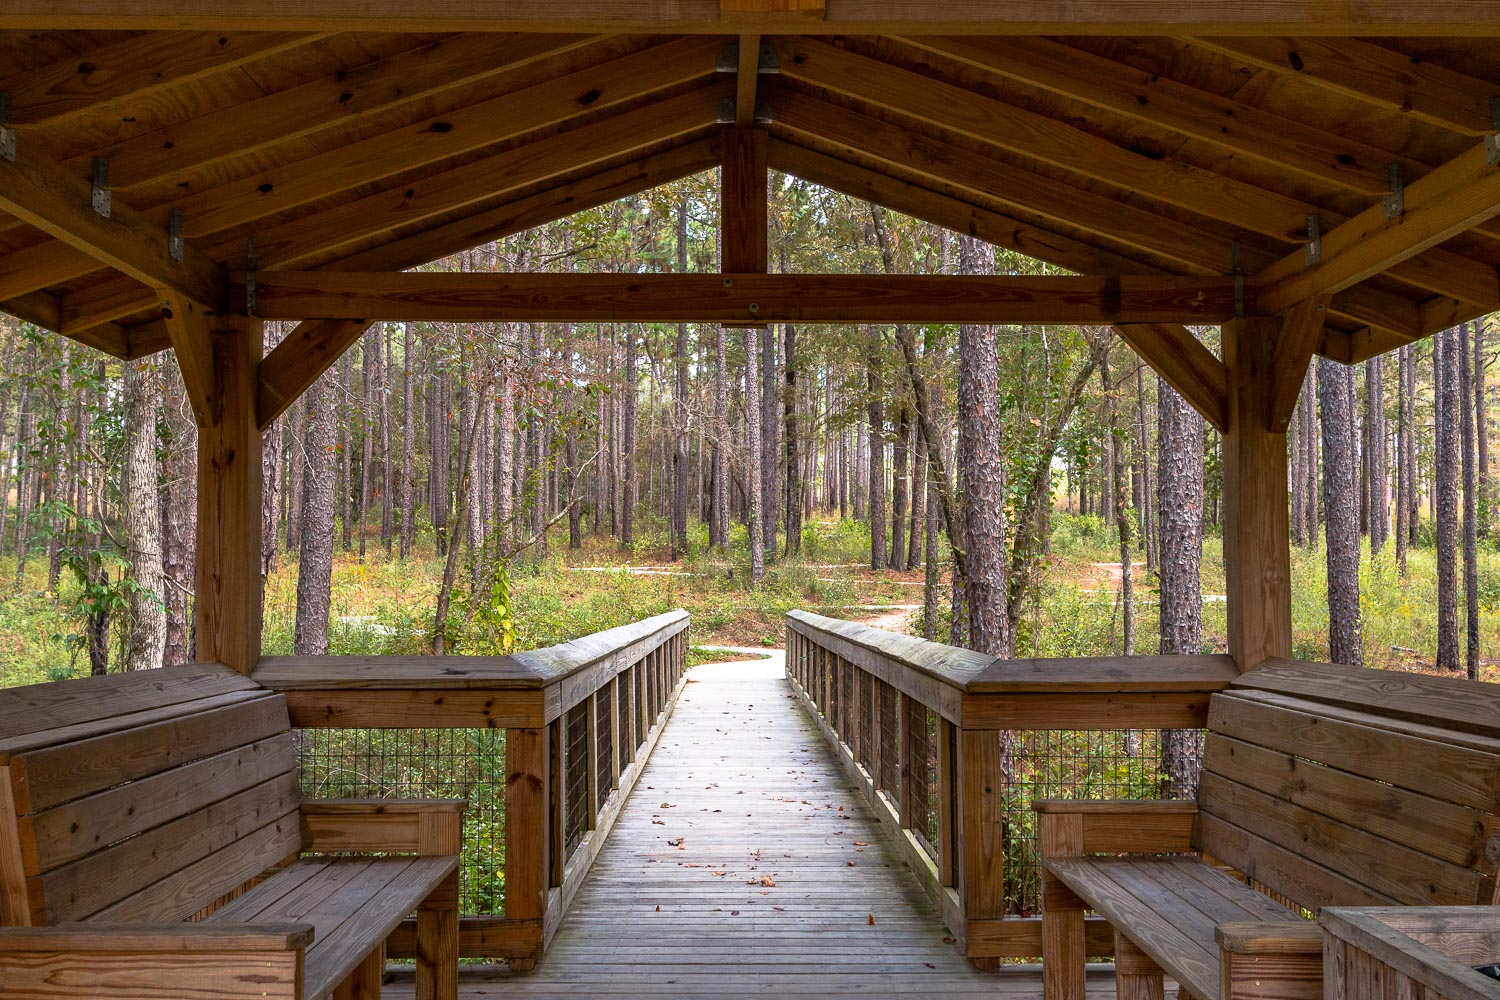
[0,664,464,1000]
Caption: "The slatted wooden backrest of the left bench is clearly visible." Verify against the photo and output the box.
[0,664,303,925]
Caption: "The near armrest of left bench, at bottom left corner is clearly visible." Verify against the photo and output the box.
[0,924,314,963]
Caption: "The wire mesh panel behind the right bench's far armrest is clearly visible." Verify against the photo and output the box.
[996,729,1202,916]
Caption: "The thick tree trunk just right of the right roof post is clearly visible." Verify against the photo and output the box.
[1317,358,1365,666]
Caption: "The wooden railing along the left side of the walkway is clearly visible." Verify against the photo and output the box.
[252,610,689,970]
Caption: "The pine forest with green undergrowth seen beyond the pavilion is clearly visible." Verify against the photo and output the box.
[0,172,1500,685]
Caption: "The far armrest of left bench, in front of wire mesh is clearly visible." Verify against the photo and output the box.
[302,799,468,856]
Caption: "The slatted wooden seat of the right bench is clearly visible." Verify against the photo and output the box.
[1046,855,1322,1000]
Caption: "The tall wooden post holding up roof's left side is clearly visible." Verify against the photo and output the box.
[194,316,261,673]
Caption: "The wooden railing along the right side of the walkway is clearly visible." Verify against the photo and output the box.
[786,612,1236,963]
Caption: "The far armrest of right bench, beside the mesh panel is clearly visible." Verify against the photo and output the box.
[1032,799,1199,858]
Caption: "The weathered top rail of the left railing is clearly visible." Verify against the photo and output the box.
[251,609,689,691]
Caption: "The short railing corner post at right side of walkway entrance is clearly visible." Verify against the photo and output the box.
[939,727,1002,971]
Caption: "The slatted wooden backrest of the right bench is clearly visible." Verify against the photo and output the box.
[1194,661,1500,910]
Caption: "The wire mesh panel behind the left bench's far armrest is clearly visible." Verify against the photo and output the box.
[297,729,506,916]
